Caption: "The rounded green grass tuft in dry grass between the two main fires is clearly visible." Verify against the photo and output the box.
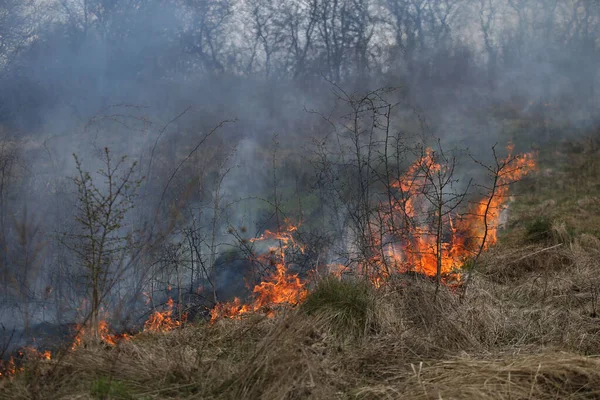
[301,277,375,337]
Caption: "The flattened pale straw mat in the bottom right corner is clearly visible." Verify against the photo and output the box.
[356,352,600,400]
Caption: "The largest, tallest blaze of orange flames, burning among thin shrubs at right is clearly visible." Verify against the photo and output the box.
[375,144,537,279]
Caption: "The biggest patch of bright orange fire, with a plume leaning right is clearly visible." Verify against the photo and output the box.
[372,145,536,286]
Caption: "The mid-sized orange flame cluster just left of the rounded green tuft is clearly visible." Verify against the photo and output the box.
[211,220,308,322]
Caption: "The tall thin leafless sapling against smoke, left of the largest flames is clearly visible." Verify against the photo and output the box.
[313,85,403,278]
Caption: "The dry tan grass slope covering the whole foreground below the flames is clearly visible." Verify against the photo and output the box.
[0,138,600,399]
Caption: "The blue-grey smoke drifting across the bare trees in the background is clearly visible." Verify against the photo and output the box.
[0,0,600,350]
